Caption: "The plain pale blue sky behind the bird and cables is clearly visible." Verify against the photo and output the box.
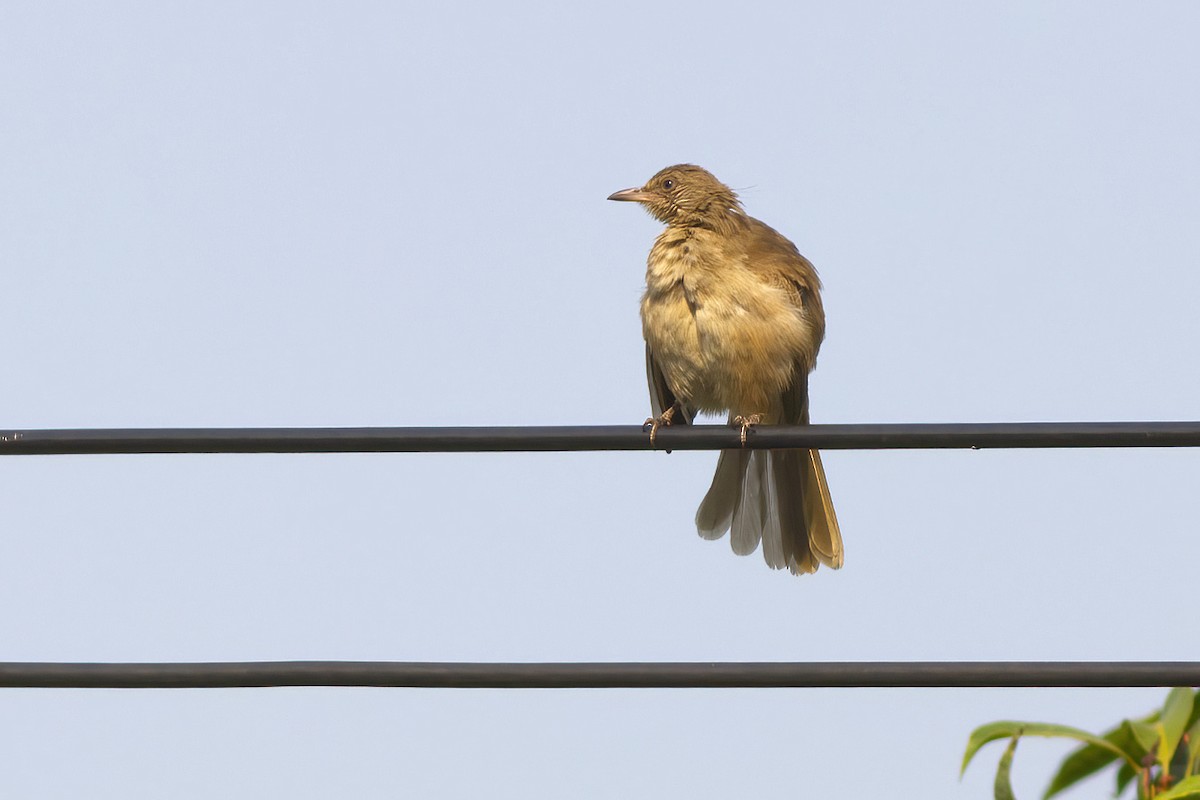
[0,1,1200,799]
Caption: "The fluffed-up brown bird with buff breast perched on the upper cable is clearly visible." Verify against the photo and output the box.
[608,164,842,575]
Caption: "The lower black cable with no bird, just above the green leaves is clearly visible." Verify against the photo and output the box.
[0,661,1200,688]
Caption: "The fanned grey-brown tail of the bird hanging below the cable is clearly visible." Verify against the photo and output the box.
[696,450,842,575]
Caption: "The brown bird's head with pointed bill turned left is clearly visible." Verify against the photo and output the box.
[608,164,742,227]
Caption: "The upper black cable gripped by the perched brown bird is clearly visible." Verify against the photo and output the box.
[0,422,1200,456]
